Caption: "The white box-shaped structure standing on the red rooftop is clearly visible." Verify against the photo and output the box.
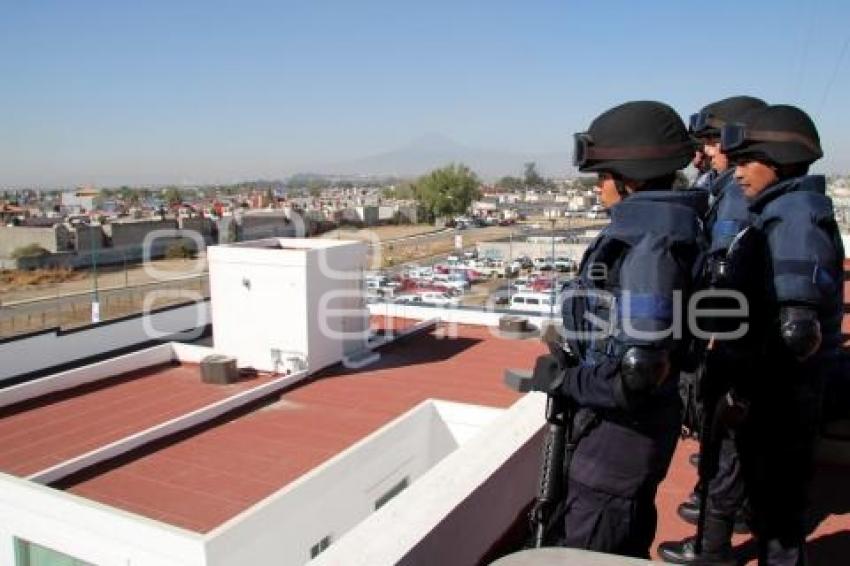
[207,238,369,378]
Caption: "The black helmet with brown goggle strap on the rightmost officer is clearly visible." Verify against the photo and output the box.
[720,104,823,165]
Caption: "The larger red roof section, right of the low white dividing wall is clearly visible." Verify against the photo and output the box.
[65,326,545,532]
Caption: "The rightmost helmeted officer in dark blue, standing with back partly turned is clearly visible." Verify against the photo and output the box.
[721,105,844,565]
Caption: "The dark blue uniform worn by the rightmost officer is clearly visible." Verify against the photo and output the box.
[735,176,844,564]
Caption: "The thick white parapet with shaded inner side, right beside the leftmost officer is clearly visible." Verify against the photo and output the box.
[310,393,546,566]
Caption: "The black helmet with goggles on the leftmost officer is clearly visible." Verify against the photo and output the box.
[573,101,694,181]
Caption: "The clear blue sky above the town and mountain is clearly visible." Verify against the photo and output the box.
[0,0,850,187]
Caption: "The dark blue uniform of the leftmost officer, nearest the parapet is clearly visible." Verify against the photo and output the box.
[563,191,707,557]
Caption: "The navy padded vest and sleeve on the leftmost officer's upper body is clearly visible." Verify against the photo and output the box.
[562,191,707,374]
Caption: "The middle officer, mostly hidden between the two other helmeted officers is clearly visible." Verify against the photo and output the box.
[658,96,767,564]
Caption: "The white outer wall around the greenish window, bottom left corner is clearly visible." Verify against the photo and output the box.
[0,473,205,566]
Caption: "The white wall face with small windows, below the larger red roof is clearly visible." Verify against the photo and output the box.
[202,401,503,566]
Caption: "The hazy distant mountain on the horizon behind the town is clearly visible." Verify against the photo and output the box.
[315,133,574,179]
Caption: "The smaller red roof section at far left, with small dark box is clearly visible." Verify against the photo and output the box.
[0,364,270,476]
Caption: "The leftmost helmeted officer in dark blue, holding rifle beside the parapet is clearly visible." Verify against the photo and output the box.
[555,101,707,558]
